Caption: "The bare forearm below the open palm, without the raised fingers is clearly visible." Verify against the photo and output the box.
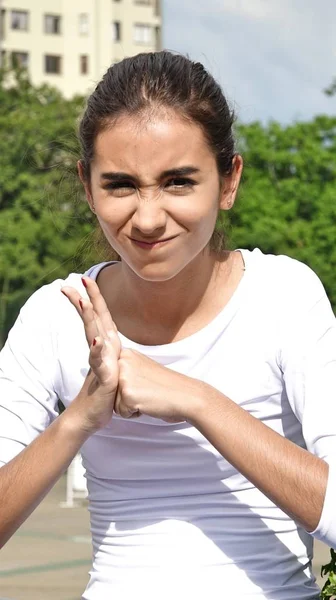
[0,361,121,548]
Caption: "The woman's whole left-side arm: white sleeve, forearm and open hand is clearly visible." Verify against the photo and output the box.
[0,280,120,547]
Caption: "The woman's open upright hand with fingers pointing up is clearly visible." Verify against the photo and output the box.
[61,277,121,434]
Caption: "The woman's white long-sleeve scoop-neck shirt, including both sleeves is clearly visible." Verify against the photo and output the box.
[0,250,336,600]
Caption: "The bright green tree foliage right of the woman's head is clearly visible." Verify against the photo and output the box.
[230,116,336,308]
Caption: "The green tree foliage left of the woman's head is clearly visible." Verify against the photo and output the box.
[0,70,98,347]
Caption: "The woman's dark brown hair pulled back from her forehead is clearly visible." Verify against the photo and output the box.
[79,51,235,252]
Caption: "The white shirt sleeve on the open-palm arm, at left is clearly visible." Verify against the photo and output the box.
[0,286,58,466]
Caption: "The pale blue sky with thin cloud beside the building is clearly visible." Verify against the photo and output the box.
[163,0,336,123]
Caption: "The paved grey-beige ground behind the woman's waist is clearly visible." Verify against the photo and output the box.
[0,478,329,600]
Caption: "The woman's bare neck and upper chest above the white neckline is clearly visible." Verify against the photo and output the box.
[98,252,242,345]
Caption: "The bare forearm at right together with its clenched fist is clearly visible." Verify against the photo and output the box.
[115,350,328,531]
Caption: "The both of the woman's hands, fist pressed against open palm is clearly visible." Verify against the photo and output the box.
[61,277,206,433]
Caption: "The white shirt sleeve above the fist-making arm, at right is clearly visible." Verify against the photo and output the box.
[280,263,336,547]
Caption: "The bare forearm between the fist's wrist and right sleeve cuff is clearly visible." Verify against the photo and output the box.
[190,385,329,531]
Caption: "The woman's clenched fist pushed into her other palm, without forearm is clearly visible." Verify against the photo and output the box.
[114,349,206,423]
